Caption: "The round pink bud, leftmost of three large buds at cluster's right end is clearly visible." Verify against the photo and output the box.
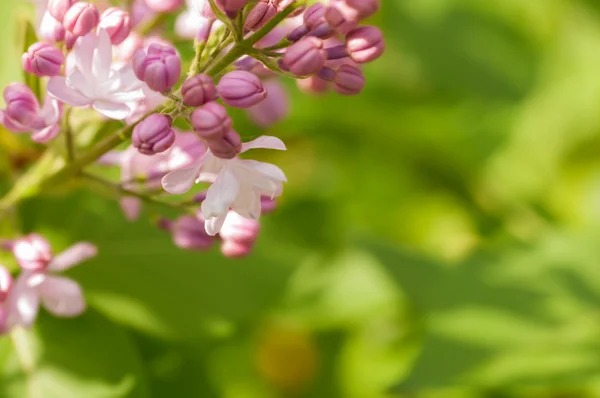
[283,37,327,76]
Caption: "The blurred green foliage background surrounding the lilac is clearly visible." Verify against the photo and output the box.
[0,0,600,398]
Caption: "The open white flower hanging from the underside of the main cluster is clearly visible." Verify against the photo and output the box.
[162,136,287,236]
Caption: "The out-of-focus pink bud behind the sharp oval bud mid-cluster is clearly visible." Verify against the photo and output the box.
[248,80,289,128]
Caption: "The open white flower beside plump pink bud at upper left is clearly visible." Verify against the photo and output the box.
[48,29,144,119]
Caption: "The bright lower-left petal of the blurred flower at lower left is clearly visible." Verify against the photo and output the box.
[7,272,40,328]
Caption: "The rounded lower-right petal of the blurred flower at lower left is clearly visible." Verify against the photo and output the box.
[38,276,85,317]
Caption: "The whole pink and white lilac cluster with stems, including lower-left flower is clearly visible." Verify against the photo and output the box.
[0,0,385,329]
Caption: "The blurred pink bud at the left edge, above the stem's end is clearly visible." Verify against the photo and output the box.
[3,83,40,132]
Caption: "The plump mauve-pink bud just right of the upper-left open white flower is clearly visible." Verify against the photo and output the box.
[132,43,181,93]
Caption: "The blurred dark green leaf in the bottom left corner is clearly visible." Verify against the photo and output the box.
[0,311,148,398]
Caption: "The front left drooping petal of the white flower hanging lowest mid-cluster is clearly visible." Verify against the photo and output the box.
[201,168,240,220]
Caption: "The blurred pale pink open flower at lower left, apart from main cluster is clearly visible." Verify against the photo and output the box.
[6,234,97,327]
